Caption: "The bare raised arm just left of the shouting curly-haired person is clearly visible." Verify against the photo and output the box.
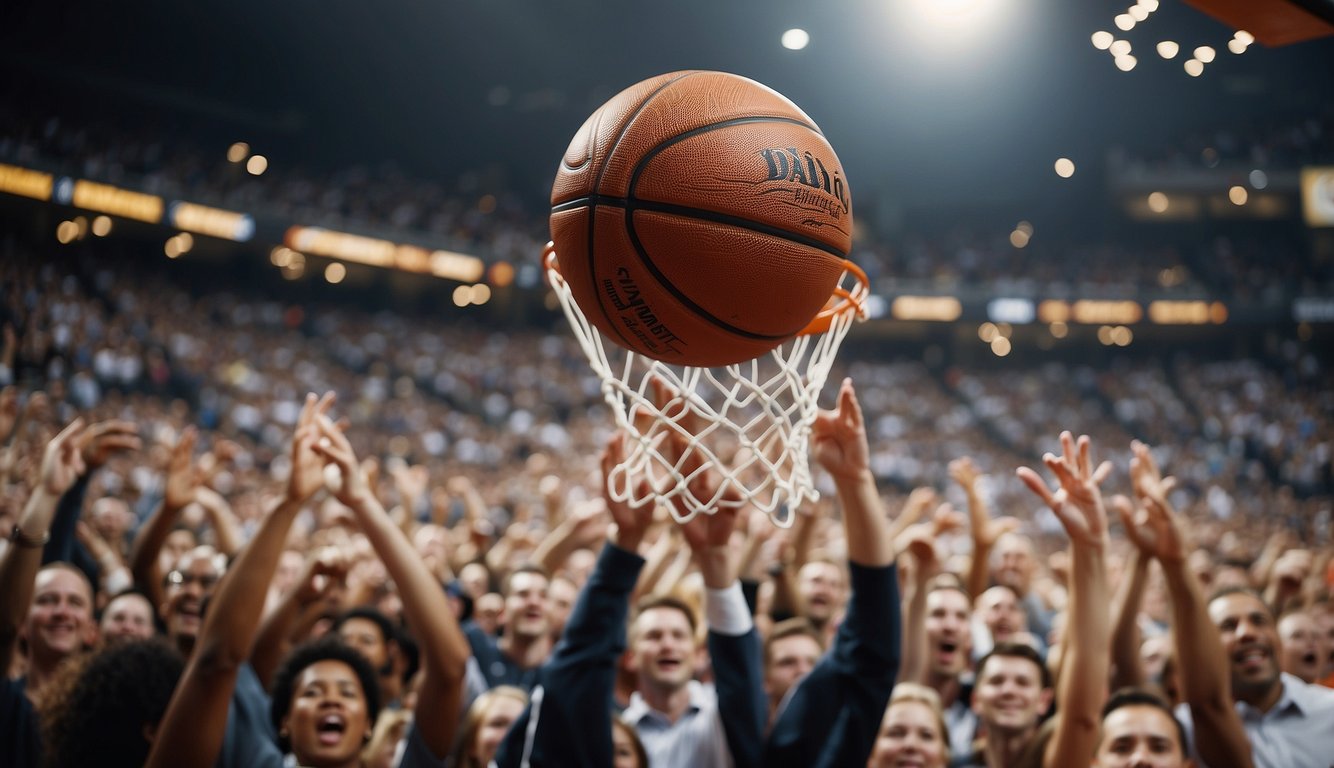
[147,395,334,768]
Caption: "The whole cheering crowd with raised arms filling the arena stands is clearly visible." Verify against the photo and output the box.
[0,109,1334,768]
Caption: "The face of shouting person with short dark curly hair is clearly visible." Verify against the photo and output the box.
[281,659,371,767]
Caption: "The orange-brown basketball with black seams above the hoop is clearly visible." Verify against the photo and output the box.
[551,71,852,367]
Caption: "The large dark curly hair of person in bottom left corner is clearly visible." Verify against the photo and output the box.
[41,637,185,768]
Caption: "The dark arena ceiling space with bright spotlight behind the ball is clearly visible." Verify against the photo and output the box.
[0,0,1334,223]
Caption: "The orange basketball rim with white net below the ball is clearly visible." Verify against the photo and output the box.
[543,243,870,528]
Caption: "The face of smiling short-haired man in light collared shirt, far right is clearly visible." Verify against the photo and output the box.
[1209,592,1281,705]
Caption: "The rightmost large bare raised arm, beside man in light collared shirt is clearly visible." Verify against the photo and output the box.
[1122,441,1251,768]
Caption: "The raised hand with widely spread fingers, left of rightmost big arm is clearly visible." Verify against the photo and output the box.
[1017,431,1111,548]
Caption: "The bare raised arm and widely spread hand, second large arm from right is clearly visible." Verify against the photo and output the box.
[1018,432,1111,768]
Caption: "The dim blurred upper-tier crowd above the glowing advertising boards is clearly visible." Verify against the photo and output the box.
[0,115,1334,301]
